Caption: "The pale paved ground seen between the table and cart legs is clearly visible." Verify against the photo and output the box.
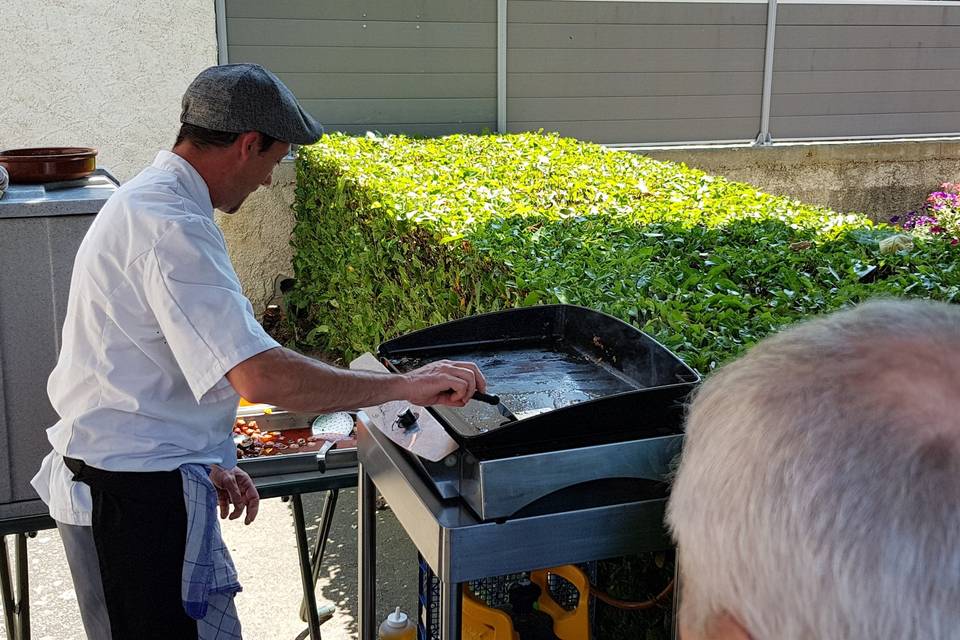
[0,490,417,640]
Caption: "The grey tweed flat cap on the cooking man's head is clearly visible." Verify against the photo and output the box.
[180,64,323,144]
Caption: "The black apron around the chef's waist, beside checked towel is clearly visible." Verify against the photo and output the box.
[64,458,197,640]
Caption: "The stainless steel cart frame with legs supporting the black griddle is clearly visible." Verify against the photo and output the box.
[357,413,672,640]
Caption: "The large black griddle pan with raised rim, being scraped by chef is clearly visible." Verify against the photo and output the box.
[379,304,700,458]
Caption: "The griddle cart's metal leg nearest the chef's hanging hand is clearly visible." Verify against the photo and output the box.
[357,464,377,640]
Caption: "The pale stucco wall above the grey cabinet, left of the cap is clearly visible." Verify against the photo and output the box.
[0,0,217,180]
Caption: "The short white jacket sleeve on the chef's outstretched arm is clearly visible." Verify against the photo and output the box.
[144,215,280,402]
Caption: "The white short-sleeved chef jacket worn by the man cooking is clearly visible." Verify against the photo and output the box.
[33,151,279,525]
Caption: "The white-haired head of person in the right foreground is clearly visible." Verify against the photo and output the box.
[668,300,960,640]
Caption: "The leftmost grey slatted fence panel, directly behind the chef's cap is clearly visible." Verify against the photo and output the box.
[226,0,497,135]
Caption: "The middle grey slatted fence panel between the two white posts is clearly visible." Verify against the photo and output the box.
[507,0,766,143]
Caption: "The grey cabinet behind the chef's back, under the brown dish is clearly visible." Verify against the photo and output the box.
[0,171,117,521]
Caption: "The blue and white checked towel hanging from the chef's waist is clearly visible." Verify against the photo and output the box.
[180,464,242,640]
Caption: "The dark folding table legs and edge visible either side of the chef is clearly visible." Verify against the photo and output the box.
[0,466,357,640]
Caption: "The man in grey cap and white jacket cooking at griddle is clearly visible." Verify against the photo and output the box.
[33,64,486,640]
